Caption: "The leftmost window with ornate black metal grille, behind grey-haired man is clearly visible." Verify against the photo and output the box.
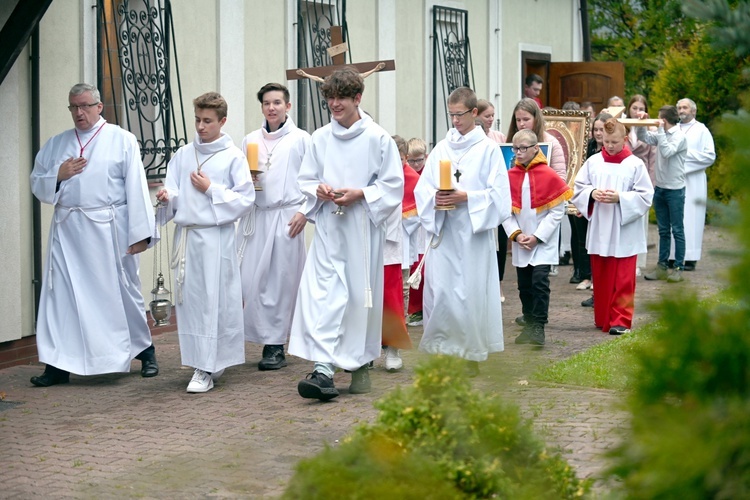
[97,0,187,180]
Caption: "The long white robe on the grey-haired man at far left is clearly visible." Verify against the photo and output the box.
[31,118,156,375]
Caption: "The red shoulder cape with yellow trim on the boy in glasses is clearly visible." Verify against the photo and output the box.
[508,150,573,214]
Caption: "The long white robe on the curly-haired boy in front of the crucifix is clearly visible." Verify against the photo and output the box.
[289,110,404,370]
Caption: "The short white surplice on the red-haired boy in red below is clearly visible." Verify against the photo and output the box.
[572,153,654,257]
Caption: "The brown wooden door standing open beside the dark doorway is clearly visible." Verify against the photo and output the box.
[548,62,627,112]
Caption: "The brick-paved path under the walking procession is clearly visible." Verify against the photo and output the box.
[0,226,732,498]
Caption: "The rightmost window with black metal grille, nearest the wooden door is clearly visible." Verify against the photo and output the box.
[431,5,474,146]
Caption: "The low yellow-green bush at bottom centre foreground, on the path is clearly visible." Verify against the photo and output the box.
[284,356,590,499]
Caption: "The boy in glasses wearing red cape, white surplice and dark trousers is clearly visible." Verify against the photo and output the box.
[503,129,573,346]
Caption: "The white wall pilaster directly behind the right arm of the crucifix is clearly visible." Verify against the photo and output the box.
[377,0,398,135]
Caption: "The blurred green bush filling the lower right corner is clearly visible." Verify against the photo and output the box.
[612,106,750,498]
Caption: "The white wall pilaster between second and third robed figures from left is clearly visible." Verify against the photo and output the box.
[216,0,245,145]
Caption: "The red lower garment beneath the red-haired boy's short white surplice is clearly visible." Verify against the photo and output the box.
[591,255,637,332]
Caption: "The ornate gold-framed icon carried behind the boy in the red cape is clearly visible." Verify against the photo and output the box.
[542,109,591,187]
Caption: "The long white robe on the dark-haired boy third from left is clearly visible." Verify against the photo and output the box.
[237,115,310,345]
